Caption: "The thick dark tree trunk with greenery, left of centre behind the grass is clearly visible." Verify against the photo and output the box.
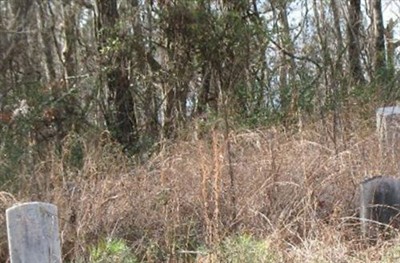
[97,0,138,153]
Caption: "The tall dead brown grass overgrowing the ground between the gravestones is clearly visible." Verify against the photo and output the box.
[0,116,397,262]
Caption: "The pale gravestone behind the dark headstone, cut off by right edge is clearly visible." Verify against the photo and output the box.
[376,106,400,160]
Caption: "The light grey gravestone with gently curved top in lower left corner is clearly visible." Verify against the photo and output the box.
[6,202,61,263]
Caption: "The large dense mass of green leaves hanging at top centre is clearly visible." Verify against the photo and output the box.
[159,0,267,119]
